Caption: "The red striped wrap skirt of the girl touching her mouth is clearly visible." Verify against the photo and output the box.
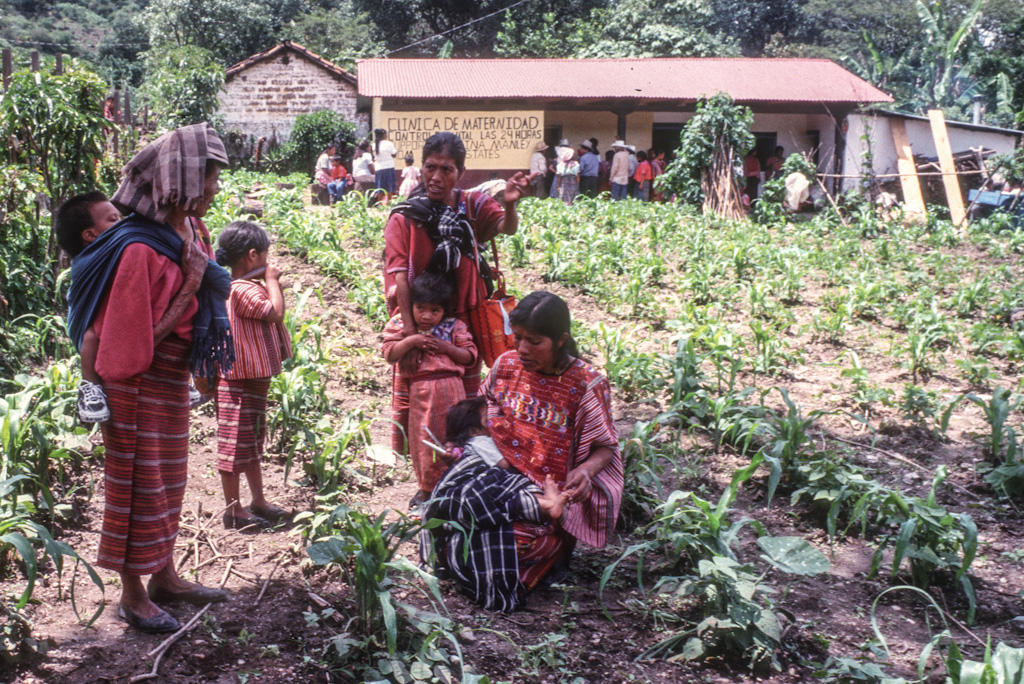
[217,378,270,473]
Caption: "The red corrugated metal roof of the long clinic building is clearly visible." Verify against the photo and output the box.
[357,57,892,103]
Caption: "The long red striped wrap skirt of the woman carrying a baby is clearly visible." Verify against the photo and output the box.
[96,335,188,574]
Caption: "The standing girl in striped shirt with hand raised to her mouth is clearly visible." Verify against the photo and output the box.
[216,221,292,531]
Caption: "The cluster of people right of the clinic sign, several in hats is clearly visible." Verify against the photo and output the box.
[529,138,666,204]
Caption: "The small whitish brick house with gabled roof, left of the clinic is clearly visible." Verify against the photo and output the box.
[218,40,369,152]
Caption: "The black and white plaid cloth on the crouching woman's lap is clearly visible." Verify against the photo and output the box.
[420,443,542,612]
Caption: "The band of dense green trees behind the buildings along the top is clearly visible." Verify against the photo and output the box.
[0,0,1024,125]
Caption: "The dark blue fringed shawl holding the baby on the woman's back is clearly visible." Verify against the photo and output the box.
[68,214,234,379]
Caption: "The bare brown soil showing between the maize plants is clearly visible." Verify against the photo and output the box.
[0,202,1024,683]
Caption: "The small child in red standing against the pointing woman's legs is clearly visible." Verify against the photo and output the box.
[382,272,476,508]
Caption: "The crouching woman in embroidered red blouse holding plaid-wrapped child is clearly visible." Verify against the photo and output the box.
[421,292,623,612]
